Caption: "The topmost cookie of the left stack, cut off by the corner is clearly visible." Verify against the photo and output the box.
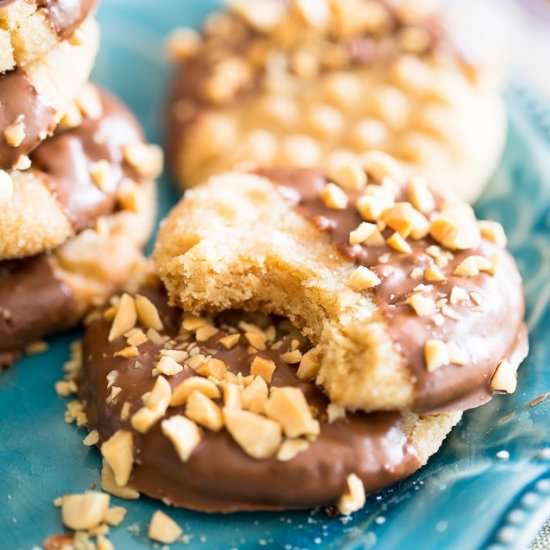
[0,0,96,73]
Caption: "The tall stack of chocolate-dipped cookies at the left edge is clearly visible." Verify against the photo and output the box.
[0,0,161,366]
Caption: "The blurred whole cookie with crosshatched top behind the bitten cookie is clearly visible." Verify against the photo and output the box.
[168,0,506,201]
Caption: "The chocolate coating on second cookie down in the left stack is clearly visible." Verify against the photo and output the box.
[0,69,56,169]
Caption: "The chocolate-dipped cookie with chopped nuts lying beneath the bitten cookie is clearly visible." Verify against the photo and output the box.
[75,286,460,514]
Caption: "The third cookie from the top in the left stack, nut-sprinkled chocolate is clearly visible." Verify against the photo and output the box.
[0,85,162,259]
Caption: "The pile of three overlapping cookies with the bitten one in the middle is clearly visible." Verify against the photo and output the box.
[70,0,528,520]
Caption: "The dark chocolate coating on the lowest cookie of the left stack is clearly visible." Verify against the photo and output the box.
[0,254,74,367]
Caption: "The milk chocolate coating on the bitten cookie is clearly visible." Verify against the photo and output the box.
[259,169,528,412]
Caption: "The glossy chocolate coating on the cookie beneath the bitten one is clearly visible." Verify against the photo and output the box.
[80,291,420,512]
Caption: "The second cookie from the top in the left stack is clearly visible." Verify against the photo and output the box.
[0,16,99,171]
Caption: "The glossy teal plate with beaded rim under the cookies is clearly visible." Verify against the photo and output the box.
[0,0,550,550]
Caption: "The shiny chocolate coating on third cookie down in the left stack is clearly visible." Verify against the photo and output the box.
[31,91,143,232]
